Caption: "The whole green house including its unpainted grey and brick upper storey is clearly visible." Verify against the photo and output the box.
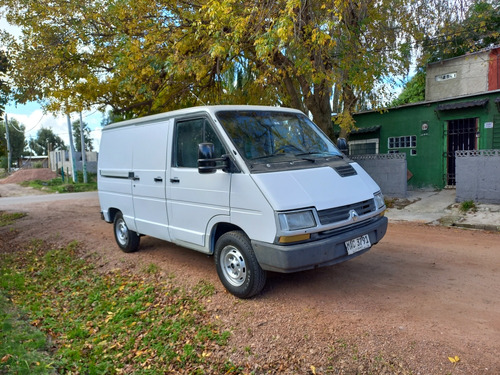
[348,46,500,191]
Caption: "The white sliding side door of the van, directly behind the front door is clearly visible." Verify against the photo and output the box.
[132,121,170,241]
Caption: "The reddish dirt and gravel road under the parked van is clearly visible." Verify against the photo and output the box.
[0,198,500,375]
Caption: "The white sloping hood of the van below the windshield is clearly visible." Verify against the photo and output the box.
[251,163,380,211]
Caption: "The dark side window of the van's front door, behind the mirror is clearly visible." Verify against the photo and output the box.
[174,118,226,168]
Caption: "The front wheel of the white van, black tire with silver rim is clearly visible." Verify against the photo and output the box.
[214,231,267,298]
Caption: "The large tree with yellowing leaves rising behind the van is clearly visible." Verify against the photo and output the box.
[4,0,446,140]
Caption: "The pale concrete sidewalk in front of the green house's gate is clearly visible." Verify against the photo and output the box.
[386,189,500,232]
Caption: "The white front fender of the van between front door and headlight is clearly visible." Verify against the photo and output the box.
[231,173,276,243]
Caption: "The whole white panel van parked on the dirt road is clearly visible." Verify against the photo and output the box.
[98,106,387,298]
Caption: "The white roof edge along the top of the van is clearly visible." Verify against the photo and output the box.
[103,105,302,130]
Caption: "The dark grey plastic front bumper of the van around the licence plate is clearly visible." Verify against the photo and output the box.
[252,217,388,273]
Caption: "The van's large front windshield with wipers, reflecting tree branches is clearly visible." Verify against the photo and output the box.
[216,111,342,163]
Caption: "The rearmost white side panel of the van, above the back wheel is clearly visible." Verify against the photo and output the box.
[98,128,136,231]
